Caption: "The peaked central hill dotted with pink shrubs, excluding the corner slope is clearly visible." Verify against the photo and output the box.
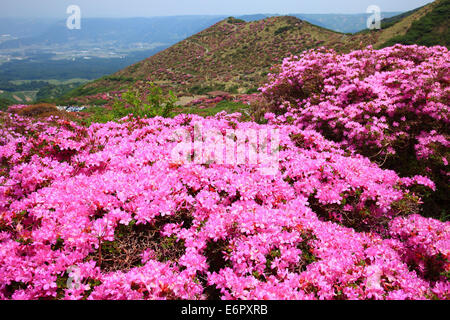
[71,16,375,99]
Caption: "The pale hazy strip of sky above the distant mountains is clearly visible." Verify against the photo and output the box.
[0,0,432,18]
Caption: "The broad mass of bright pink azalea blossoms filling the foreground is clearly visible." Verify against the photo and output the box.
[0,113,444,299]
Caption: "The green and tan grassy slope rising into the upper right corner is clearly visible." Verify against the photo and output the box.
[375,0,450,48]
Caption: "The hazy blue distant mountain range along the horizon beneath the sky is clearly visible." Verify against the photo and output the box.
[0,12,399,49]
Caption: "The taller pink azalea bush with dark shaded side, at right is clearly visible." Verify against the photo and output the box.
[261,45,450,216]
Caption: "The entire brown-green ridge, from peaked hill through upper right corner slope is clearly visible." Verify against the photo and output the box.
[55,0,449,103]
